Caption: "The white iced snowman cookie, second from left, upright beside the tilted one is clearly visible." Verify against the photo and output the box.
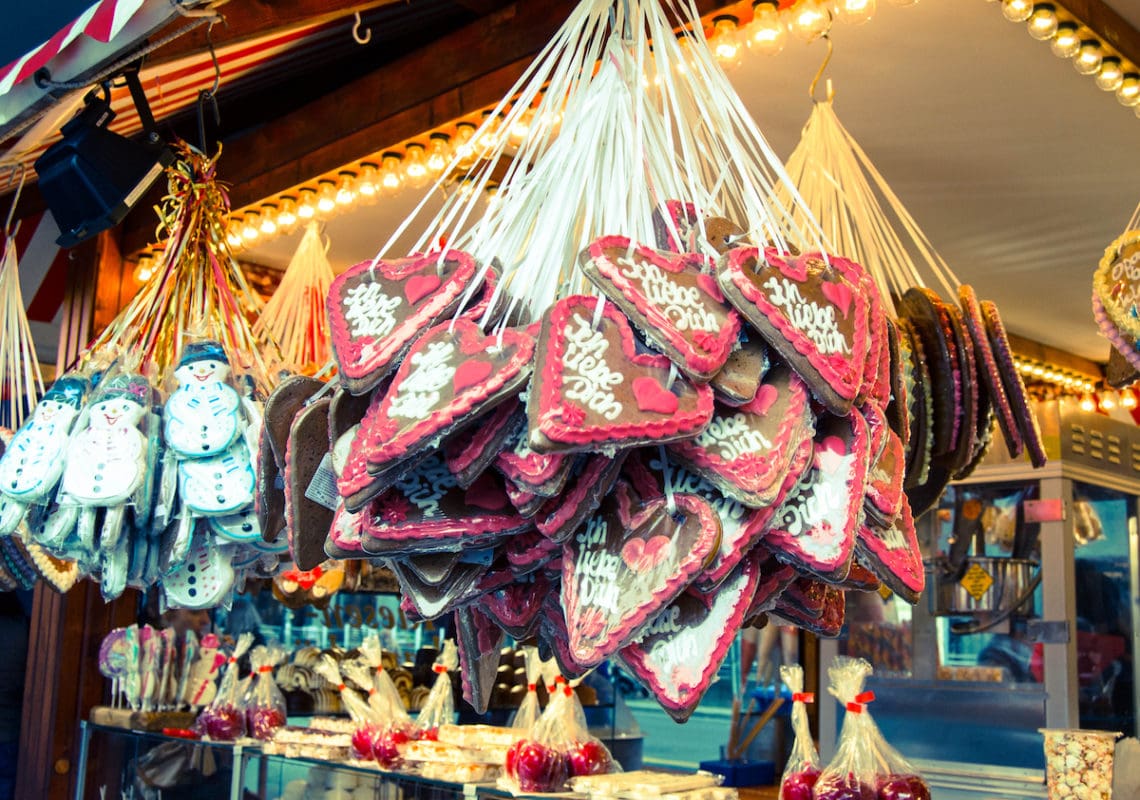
[59,375,150,550]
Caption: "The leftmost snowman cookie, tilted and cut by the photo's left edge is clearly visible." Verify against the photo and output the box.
[0,377,87,533]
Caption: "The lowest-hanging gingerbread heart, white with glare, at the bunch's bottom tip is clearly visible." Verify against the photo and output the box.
[620,557,758,723]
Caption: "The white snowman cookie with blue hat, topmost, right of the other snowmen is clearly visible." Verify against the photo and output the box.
[164,341,245,459]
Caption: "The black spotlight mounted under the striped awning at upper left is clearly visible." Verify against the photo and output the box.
[35,66,174,247]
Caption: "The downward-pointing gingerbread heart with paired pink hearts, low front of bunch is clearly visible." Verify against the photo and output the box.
[562,482,720,667]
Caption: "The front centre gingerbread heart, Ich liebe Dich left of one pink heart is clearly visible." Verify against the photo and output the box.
[527,295,713,452]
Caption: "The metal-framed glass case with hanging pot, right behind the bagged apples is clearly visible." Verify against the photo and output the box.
[820,403,1140,800]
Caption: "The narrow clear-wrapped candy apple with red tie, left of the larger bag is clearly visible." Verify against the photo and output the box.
[813,655,877,800]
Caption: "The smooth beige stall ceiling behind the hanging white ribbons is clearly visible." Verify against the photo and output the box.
[238,0,1140,360]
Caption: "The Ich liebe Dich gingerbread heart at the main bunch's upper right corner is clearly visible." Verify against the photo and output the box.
[717,247,870,415]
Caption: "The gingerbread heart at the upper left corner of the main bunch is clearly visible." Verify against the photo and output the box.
[326,250,477,394]
